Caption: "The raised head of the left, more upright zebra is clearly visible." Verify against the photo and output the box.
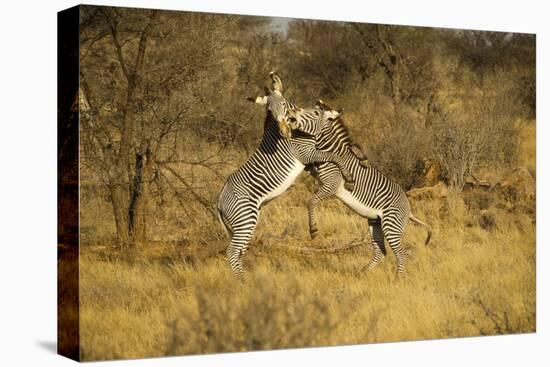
[247,71,293,139]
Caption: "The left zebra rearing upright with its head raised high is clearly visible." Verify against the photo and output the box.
[217,72,353,278]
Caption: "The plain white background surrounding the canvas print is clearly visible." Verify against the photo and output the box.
[0,0,550,366]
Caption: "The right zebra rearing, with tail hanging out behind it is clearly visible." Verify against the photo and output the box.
[287,101,432,274]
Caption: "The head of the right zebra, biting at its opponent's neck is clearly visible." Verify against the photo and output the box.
[287,101,340,138]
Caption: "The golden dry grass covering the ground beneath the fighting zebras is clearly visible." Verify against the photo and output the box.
[80,185,535,360]
